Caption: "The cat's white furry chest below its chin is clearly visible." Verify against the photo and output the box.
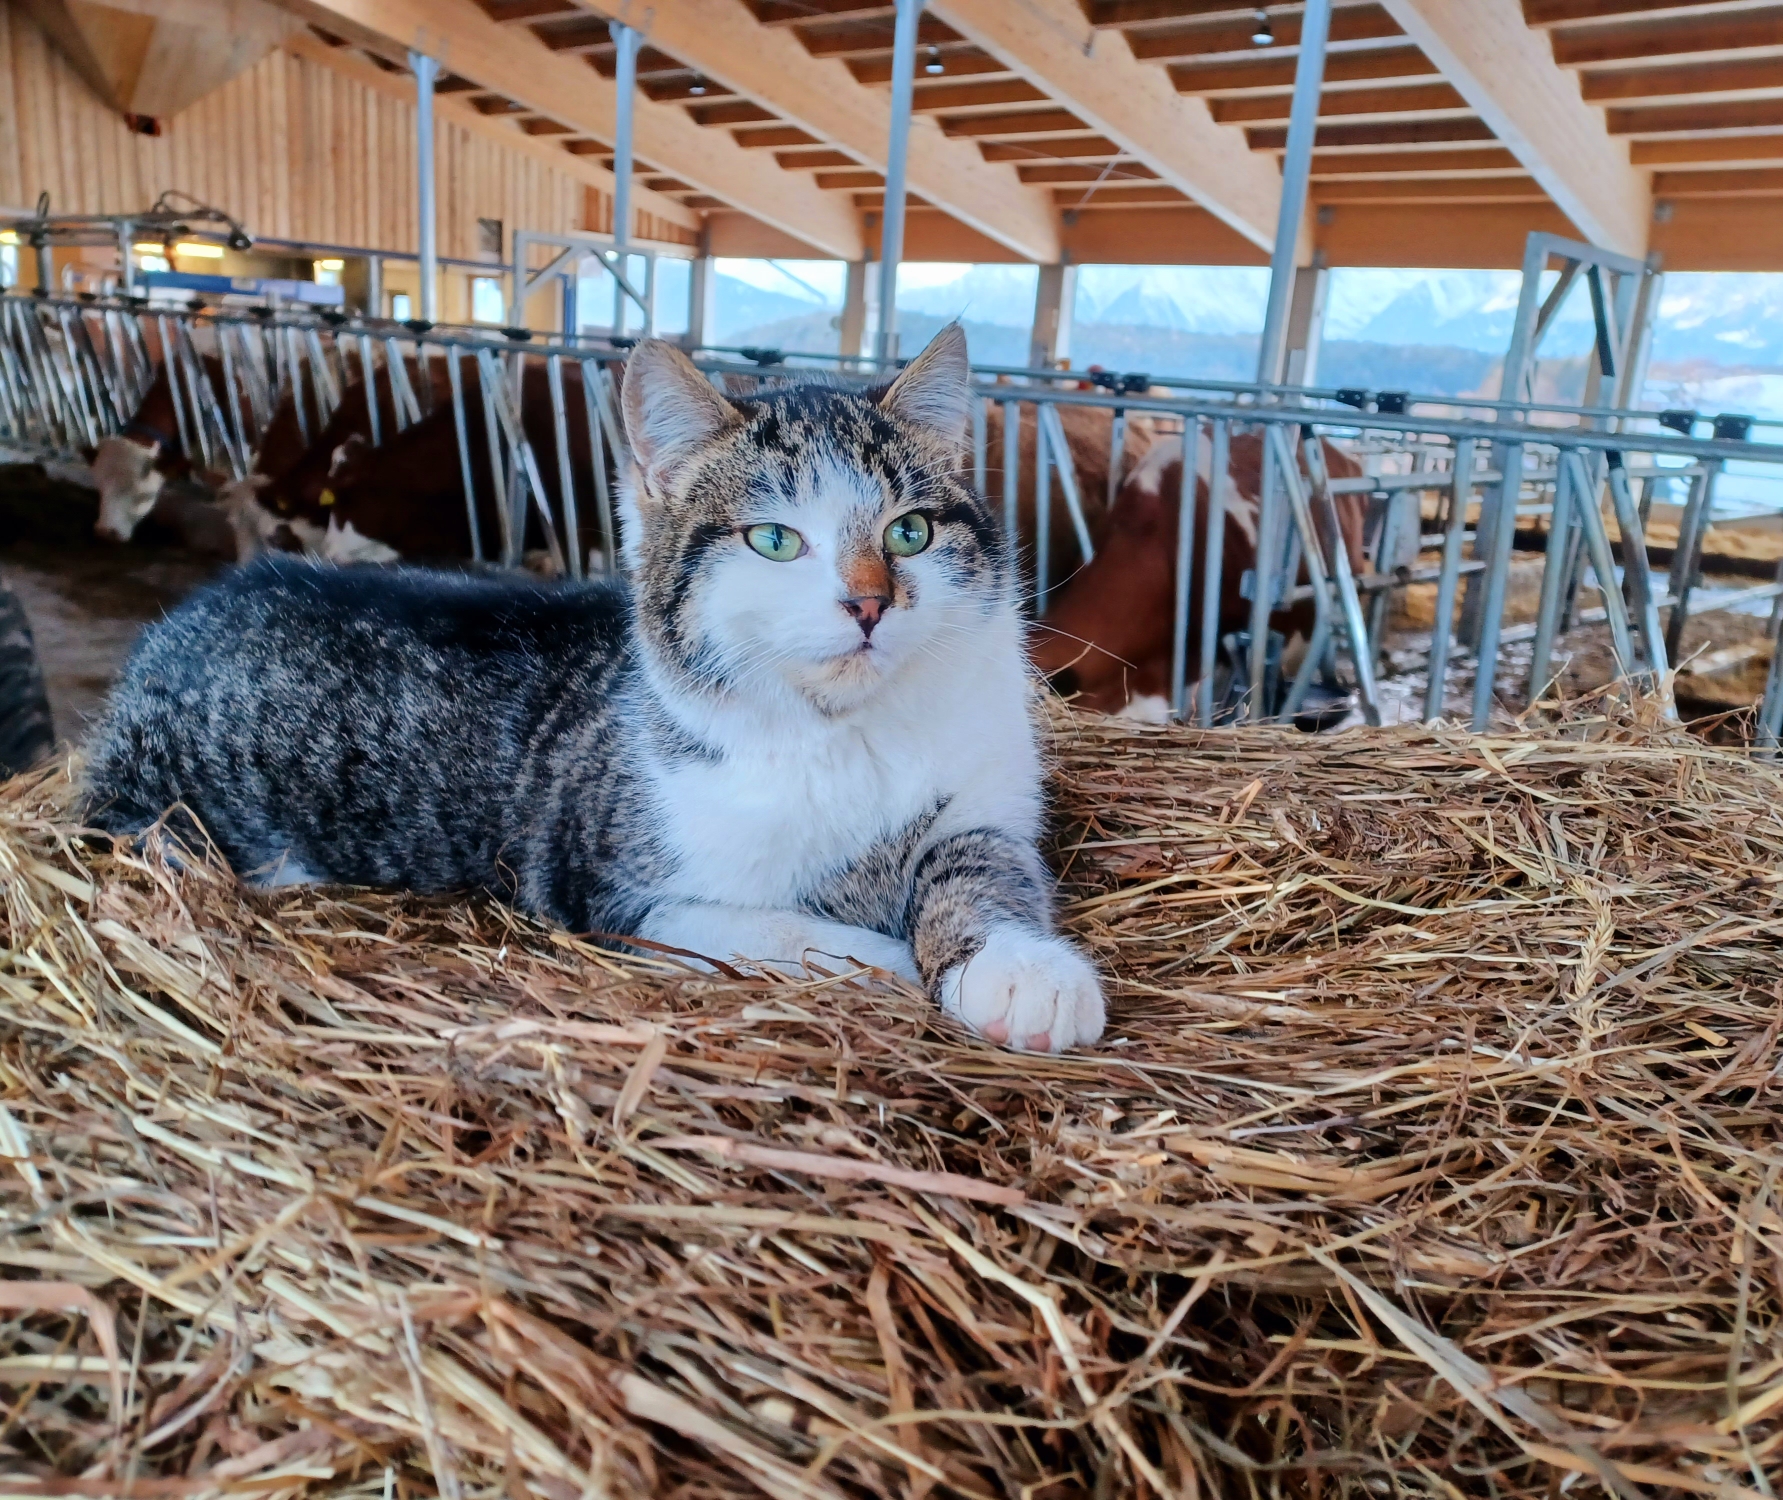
[654,638,1039,906]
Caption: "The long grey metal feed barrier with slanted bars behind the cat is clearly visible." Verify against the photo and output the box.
[0,296,1783,751]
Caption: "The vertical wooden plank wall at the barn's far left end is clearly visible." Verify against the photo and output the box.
[0,0,659,260]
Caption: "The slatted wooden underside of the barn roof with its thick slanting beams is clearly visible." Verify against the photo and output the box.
[285,0,1783,269]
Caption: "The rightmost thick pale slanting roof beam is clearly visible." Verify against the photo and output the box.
[1385,0,1653,255]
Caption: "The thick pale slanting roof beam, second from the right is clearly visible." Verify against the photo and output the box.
[929,0,1282,248]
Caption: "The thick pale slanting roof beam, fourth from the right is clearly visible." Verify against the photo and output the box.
[263,0,865,260]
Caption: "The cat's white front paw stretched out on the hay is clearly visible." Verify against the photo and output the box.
[940,926,1105,1052]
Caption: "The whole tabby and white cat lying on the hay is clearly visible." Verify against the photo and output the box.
[87,326,1104,1051]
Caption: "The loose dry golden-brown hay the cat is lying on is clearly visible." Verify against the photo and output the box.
[0,706,1783,1500]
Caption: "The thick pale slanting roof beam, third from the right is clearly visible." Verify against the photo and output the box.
[563,0,1059,260]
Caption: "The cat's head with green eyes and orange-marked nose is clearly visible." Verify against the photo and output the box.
[624,325,1007,713]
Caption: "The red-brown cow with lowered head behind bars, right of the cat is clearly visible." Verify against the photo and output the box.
[1029,433,1366,719]
